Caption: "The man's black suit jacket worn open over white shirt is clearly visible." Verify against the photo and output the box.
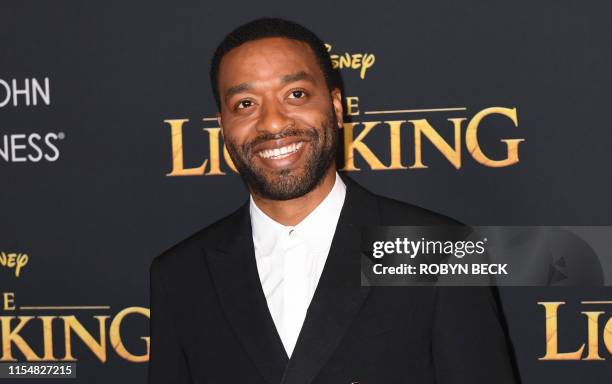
[149,177,514,384]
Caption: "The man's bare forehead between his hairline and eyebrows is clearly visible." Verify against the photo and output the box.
[219,37,323,89]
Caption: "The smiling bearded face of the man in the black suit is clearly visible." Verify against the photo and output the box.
[217,37,342,200]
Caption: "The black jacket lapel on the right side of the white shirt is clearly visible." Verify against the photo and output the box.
[282,178,380,384]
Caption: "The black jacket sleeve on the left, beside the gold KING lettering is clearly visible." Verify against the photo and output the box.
[148,259,191,384]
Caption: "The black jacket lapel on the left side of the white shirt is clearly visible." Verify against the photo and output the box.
[205,203,288,384]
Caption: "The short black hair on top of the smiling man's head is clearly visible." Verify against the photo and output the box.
[210,17,338,111]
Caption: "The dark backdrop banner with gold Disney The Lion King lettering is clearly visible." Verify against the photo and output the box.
[0,1,612,383]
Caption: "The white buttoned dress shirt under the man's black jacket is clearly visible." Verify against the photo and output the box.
[249,173,346,357]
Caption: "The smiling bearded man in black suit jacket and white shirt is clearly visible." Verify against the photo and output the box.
[149,19,513,384]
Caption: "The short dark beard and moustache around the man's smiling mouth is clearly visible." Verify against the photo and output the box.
[225,109,339,200]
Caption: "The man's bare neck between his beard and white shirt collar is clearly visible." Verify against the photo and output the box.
[252,167,336,226]
